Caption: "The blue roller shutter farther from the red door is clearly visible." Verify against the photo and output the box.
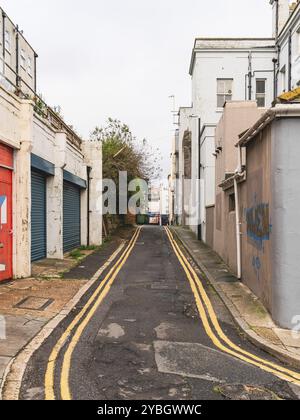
[64,181,81,252]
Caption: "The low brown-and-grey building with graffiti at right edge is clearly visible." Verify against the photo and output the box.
[237,104,300,328]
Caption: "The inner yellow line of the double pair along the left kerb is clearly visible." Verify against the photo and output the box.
[60,228,141,400]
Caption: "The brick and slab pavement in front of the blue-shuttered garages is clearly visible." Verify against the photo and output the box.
[0,229,132,394]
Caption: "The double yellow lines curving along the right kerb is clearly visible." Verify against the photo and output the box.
[165,228,300,385]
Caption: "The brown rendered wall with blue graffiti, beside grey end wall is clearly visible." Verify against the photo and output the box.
[239,126,273,311]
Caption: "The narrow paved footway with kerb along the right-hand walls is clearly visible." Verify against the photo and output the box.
[172,227,300,368]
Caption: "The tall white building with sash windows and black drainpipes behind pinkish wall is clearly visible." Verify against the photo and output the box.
[179,38,277,241]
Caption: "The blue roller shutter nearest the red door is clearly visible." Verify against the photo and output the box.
[31,171,47,261]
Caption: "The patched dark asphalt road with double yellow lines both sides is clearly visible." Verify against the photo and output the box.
[20,227,300,401]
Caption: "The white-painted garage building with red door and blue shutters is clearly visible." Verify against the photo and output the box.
[0,7,102,280]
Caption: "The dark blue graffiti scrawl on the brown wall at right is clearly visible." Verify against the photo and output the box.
[246,203,272,250]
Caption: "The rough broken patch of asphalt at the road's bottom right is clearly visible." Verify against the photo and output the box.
[217,384,279,400]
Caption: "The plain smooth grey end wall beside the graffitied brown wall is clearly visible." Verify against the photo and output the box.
[271,118,300,328]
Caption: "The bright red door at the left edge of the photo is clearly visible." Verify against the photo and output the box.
[0,144,13,281]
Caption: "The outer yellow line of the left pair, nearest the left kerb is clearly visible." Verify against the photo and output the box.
[45,228,140,400]
